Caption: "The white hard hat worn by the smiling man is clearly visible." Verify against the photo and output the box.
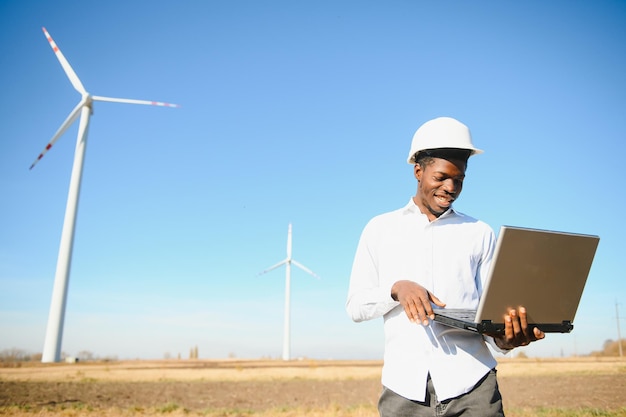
[407,117,483,165]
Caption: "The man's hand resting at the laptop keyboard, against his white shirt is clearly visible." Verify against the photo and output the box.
[391,280,446,326]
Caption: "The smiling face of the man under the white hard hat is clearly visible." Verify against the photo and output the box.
[413,158,466,221]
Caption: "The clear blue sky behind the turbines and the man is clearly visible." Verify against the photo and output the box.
[0,0,626,359]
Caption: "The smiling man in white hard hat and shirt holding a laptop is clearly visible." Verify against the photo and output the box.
[346,117,544,417]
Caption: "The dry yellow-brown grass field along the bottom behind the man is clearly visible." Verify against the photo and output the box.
[0,358,626,417]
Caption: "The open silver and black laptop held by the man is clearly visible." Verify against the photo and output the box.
[435,226,600,334]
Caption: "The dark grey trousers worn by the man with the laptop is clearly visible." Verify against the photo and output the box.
[378,369,504,417]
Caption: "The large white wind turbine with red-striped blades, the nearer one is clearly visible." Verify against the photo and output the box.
[30,28,178,362]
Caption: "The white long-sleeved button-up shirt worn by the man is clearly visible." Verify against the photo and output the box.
[346,199,499,401]
